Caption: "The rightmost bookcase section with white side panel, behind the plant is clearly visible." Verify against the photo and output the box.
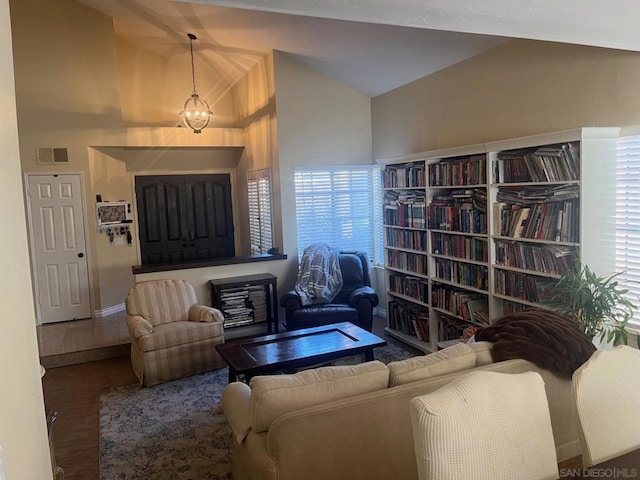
[486,128,619,319]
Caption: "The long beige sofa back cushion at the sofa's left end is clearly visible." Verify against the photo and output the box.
[249,360,389,432]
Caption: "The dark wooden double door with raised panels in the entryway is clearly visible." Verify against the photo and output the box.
[135,174,235,265]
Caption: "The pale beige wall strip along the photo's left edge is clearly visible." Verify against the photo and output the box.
[0,0,51,480]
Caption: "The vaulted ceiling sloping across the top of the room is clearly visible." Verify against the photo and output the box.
[78,0,640,97]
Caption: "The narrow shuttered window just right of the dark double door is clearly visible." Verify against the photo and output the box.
[247,168,273,254]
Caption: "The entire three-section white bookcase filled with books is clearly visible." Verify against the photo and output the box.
[379,128,619,352]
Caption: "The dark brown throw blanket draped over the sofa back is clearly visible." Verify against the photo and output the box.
[476,310,596,378]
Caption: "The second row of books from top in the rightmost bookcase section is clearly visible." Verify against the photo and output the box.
[494,199,580,242]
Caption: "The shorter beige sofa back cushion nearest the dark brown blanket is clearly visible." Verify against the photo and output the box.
[388,343,476,387]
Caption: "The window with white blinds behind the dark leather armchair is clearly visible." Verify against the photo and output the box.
[295,165,383,265]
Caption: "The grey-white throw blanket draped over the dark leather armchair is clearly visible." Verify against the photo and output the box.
[295,243,342,306]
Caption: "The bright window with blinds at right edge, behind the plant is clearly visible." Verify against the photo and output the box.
[616,136,640,326]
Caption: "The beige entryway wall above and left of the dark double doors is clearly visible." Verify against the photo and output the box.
[11,0,244,314]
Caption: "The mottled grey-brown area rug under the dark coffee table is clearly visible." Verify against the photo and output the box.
[100,345,412,480]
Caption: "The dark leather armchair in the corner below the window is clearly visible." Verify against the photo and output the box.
[280,252,378,332]
